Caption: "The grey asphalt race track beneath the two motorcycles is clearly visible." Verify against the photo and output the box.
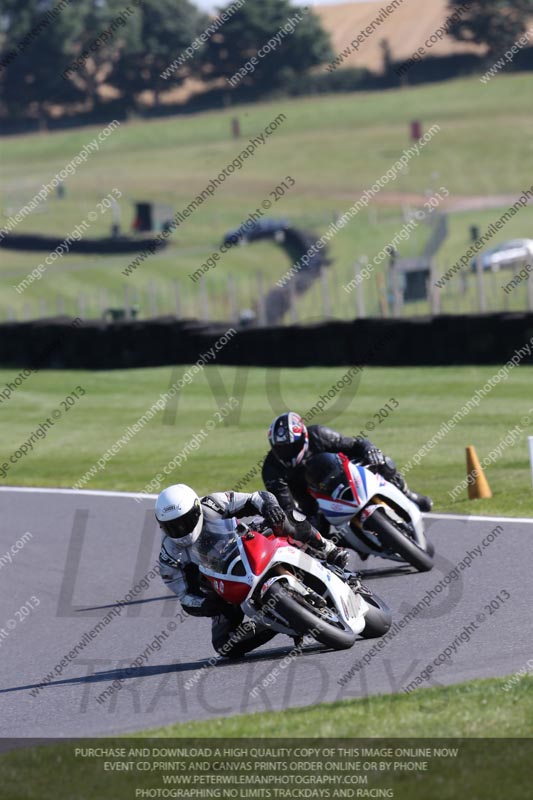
[0,487,533,738]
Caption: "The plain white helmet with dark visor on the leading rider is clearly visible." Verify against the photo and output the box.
[155,483,204,547]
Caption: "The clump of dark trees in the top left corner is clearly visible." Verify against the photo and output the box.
[0,0,209,115]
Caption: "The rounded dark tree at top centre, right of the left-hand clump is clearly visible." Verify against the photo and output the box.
[203,0,334,93]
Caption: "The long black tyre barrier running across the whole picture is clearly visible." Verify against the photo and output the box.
[0,313,533,370]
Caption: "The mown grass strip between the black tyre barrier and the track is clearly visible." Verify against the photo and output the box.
[0,366,533,515]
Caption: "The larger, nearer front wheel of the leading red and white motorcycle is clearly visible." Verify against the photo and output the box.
[263,581,357,650]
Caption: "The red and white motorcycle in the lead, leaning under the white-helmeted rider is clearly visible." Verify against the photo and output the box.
[194,519,391,650]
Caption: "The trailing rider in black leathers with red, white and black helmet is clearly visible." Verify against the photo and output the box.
[263,411,433,533]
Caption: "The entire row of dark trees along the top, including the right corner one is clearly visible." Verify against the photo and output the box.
[0,0,533,122]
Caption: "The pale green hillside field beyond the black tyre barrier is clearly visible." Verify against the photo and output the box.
[0,74,533,318]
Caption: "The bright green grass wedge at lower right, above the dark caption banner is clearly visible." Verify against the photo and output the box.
[141,677,533,739]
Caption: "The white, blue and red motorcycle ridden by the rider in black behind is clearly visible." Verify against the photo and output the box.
[306,453,435,572]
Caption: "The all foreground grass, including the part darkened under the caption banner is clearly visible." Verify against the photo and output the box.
[0,678,533,800]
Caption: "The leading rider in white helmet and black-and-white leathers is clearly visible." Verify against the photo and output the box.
[155,483,347,657]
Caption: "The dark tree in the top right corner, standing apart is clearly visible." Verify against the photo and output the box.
[448,0,533,57]
